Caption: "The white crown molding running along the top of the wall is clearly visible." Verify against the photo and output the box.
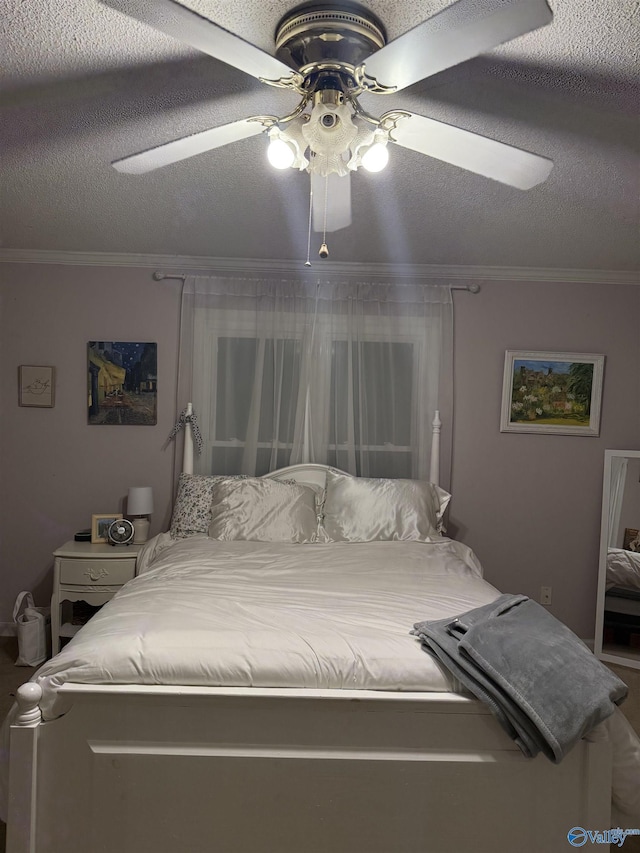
[0,249,640,285]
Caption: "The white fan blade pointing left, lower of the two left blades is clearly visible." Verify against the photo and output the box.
[111,118,265,175]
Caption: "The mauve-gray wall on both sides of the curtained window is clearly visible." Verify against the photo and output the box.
[0,264,640,637]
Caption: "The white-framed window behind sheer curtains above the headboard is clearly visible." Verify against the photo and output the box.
[192,311,428,477]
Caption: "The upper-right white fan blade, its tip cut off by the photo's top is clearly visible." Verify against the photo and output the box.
[364,0,553,91]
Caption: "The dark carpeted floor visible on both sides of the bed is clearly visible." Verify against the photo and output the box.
[0,637,640,853]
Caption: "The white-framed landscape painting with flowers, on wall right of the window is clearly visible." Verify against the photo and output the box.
[500,350,604,435]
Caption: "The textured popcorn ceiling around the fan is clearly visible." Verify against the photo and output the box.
[0,0,640,270]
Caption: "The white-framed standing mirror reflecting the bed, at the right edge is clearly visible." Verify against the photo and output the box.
[594,450,640,669]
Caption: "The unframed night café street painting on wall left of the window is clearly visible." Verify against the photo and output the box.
[87,341,158,426]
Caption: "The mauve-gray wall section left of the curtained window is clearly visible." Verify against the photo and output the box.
[0,264,180,622]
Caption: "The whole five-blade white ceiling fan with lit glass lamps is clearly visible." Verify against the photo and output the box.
[100,0,553,248]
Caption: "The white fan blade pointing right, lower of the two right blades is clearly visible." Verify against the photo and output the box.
[391,113,553,190]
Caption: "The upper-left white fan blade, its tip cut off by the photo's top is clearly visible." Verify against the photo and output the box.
[100,0,295,85]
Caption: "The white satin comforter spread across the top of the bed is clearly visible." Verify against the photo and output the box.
[36,534,498,719]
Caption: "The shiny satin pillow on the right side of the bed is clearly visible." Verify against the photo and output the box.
[323,470,451,542]
